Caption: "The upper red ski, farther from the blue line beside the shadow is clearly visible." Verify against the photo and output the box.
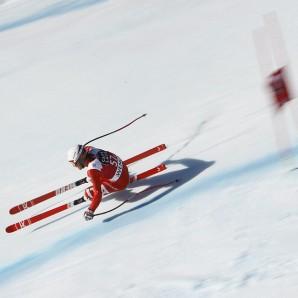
[9,144,167,214]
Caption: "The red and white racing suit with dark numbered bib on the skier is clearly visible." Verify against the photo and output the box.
[85,146,129,211]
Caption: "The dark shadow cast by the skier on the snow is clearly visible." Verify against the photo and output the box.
[103,158,215,222]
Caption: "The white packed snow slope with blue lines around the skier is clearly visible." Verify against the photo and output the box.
[0,0,298,298]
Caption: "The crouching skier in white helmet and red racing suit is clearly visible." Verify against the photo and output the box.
[67,145,129,220]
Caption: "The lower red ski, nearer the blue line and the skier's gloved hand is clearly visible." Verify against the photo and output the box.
[5,164,166,233]
